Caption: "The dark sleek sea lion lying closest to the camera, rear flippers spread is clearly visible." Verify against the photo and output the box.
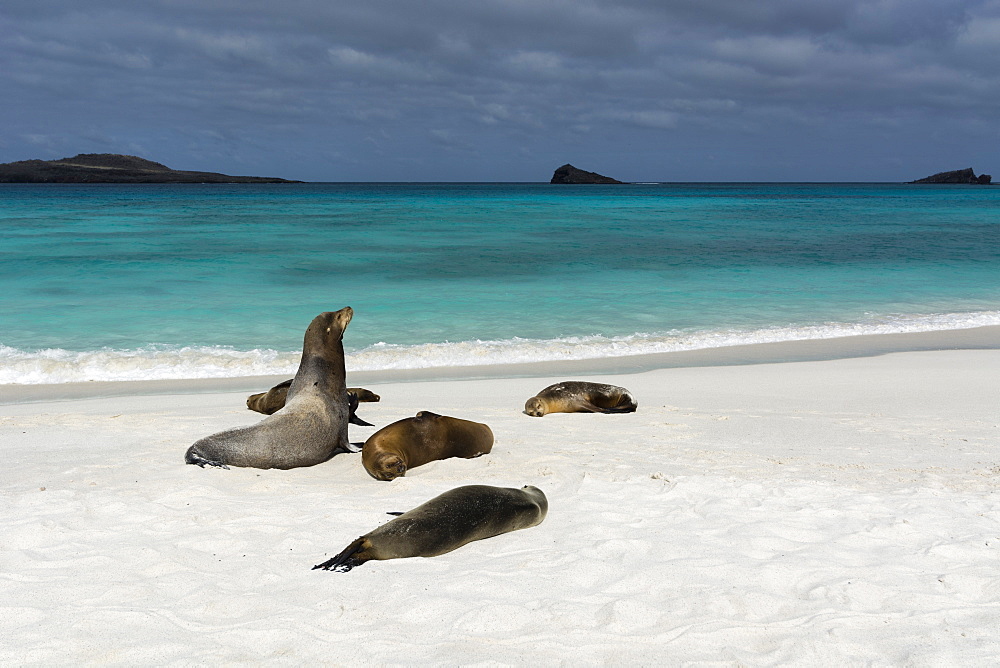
[313,485,549,573]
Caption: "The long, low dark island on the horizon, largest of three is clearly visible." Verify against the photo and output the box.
[0,153,301,183]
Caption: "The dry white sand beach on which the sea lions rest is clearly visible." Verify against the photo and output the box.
[0,336,1000,666]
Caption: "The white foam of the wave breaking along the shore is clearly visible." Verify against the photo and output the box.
[0,311,1000,384]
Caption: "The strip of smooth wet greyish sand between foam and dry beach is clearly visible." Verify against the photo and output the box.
[0,326,1000,406]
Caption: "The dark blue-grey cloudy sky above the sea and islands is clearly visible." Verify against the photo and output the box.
[0,0,1000,181]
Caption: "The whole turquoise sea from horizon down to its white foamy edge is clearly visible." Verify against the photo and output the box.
[0,183,1000,383]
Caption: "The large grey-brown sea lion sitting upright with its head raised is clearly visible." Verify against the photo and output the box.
[184,306,354,469]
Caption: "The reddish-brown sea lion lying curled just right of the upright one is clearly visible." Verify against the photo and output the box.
[361,411,493,480]
